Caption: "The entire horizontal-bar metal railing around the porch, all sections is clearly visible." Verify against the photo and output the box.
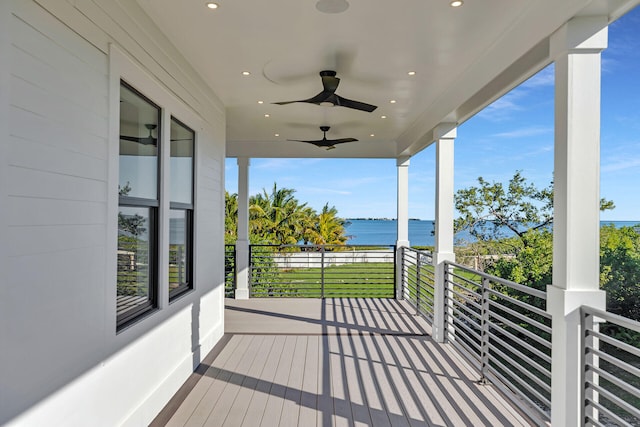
[225,245,640,426]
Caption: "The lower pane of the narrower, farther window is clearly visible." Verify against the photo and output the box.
[169,209,191,292]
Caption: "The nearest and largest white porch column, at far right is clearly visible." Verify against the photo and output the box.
[547,17,607,427]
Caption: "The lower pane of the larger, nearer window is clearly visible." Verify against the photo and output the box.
[116,206,153,317]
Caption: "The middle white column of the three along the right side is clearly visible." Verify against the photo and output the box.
[432,124,457,342]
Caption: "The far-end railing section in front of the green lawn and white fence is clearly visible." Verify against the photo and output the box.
[249,245,395,298]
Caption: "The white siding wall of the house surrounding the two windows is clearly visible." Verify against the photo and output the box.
[0,0,224,426]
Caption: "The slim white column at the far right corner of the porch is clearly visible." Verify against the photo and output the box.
[396,157,410,299]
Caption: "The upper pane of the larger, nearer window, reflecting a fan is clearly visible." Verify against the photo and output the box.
[119,85,160,199]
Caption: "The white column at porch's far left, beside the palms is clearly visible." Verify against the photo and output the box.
[235,157,250,299]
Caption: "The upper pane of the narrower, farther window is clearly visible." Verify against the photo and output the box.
[171,119,195,205]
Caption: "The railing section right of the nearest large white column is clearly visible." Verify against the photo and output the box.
[580,307,640,426]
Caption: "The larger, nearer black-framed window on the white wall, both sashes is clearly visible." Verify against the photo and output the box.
[116,82,161,329]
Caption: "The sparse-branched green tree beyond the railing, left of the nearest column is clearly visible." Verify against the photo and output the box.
[454,171,615,290]
